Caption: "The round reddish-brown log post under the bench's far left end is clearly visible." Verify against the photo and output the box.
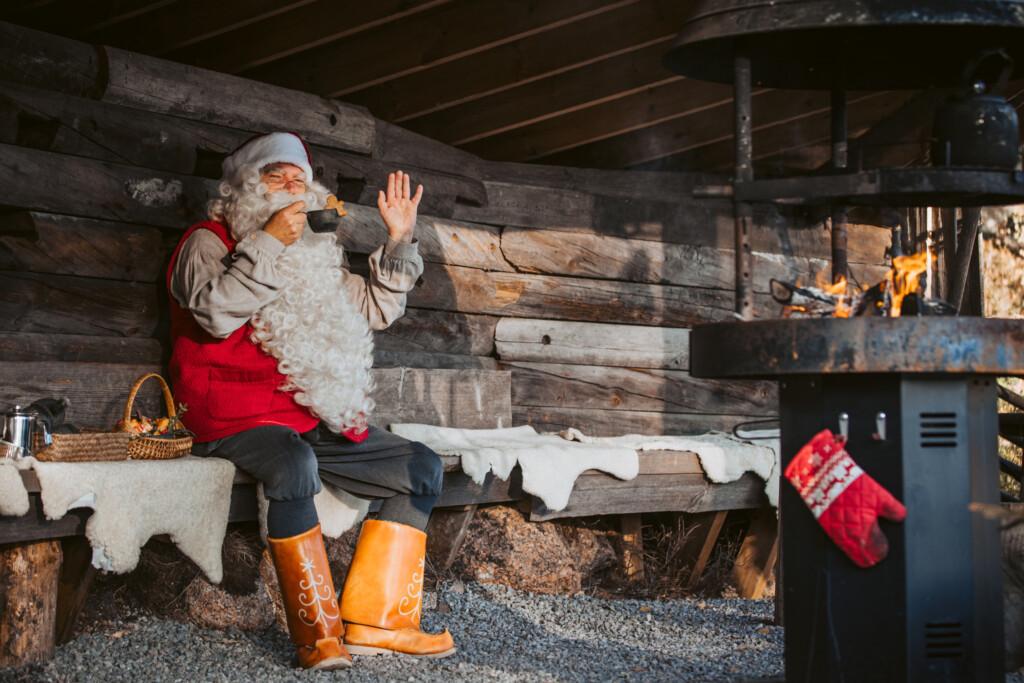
[0,540,60,667]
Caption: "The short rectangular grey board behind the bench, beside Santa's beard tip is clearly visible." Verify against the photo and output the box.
[371,368,512,429]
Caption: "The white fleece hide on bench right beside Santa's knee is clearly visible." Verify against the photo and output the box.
[390,424,640,511]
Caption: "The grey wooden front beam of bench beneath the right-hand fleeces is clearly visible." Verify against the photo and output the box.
[529,473,767,521]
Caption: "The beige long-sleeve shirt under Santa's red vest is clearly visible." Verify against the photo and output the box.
[171,230,423,339]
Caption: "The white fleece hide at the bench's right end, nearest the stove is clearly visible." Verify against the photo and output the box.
[561,428,779,507]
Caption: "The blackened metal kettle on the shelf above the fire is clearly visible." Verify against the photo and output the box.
[932,50,1020,171]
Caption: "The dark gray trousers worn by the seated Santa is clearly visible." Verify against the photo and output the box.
[193,424,443,538]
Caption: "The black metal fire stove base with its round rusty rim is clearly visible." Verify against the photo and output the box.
[690,317,1024,683]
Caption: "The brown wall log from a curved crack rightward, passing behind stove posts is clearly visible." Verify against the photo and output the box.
[502,227,885,292]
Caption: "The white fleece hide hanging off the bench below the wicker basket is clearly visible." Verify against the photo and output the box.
[34,456,234,584]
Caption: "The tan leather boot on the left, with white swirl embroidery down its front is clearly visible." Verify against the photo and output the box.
[267,524,352,670]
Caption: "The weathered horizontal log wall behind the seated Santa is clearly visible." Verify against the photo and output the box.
[0,24,888,434]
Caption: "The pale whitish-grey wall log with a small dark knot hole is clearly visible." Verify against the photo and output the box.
[495,317,690,370]
